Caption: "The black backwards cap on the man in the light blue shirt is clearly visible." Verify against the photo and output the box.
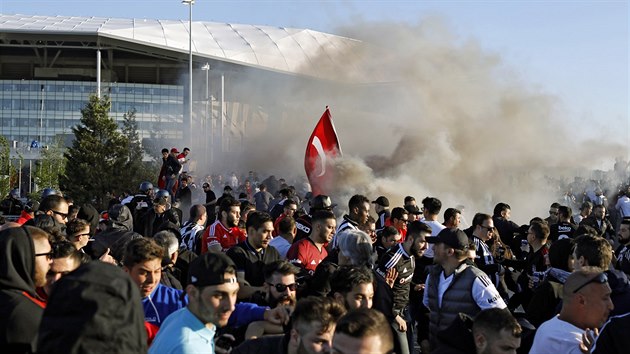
[188,253,236,287]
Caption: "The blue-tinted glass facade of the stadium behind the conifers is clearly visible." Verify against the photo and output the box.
[0,80,184,146]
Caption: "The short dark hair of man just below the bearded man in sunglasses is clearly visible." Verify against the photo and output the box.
[291,296,348,333]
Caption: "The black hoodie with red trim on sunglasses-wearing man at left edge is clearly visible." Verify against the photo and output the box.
[0,227,44,353]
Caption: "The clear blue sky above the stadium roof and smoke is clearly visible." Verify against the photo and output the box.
[0,0,630,149]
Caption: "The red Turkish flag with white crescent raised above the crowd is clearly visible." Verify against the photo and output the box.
[304,106,341,196]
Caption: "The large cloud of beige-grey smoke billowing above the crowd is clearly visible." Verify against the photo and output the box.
[207,18,624,223]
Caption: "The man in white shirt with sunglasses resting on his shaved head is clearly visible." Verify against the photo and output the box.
[530,267,614,354]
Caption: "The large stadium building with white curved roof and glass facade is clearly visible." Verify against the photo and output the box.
[0,14,360,173]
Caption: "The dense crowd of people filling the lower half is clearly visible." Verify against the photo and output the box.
[0,153,630,354]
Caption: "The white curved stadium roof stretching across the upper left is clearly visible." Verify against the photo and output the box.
[0,14,361,79]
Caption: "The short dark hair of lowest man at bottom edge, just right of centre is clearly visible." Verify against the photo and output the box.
[335,308,394,353]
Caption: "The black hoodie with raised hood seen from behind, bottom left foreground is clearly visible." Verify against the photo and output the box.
[38,261,147,354]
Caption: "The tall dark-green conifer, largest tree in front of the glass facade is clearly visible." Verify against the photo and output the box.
[60,95,129,208]
